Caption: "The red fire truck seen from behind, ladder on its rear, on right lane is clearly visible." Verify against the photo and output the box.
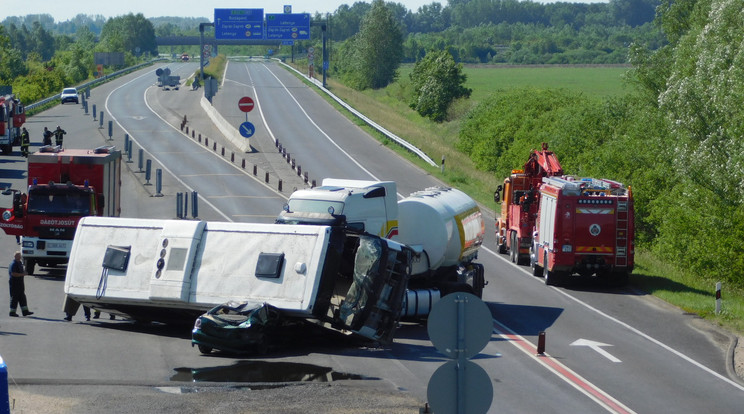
[530,176,635,285]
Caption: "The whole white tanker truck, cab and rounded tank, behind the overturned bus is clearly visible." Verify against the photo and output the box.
[277,178,486,317]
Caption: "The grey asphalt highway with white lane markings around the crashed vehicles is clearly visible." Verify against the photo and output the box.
[0,62,744,413]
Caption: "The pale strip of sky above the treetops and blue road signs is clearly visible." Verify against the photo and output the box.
[0,0,609,22]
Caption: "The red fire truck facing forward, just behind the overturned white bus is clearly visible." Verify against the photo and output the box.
[0,147,121,274]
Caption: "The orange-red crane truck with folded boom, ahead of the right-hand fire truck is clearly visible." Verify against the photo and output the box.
[493,143,563,264]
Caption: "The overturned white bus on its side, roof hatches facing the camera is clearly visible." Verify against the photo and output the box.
[65,217,412,342]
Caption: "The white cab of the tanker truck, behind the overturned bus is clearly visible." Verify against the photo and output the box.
[276,178,398,238]
